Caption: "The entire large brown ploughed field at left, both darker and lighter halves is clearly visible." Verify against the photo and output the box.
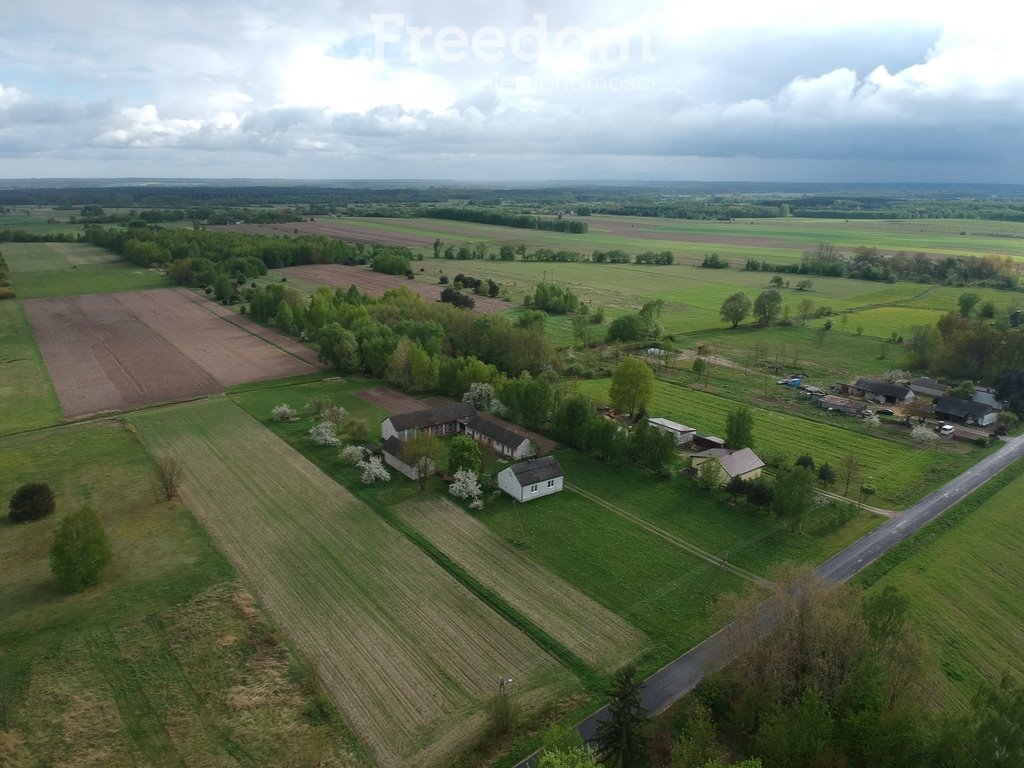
[25,290,314,419]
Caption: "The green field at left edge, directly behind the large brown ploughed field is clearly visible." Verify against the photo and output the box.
[0,243,171,299]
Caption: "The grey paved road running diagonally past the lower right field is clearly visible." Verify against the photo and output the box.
[516,436,1024,768]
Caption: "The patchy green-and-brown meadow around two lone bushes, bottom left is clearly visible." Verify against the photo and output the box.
[0,419,364,768]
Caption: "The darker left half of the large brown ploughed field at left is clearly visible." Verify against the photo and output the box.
[25,294,221,418]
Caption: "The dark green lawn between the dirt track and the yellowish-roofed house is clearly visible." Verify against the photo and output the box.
[557,449,883,578]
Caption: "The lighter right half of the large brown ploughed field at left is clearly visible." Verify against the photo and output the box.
[117,289,316,387]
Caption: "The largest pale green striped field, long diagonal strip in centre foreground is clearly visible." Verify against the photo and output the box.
[132,398,572,766]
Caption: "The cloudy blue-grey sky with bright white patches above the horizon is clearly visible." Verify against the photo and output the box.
[0,0,1024,183]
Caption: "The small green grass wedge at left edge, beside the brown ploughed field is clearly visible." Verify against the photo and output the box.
[0,299,60,434]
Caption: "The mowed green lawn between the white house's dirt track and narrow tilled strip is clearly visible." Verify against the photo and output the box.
[478,487,743,674]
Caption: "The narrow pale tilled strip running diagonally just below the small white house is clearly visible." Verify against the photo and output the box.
[396,499,644,669]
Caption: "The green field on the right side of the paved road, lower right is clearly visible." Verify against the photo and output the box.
[863,462,1024,707]
